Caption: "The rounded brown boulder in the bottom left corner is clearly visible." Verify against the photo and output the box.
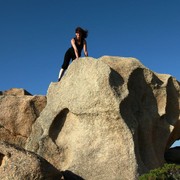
[0,142,62,180]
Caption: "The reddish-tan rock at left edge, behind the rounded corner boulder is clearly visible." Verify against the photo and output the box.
[0,88,46,147]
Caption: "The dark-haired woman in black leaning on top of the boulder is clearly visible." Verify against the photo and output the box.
[58,27,88,81]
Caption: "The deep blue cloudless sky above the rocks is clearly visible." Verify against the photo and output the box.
[0,0,180,145]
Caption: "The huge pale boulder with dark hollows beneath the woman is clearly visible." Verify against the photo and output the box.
[26,57,179,180]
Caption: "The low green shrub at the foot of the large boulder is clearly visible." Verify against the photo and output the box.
[139,164,180,180]
